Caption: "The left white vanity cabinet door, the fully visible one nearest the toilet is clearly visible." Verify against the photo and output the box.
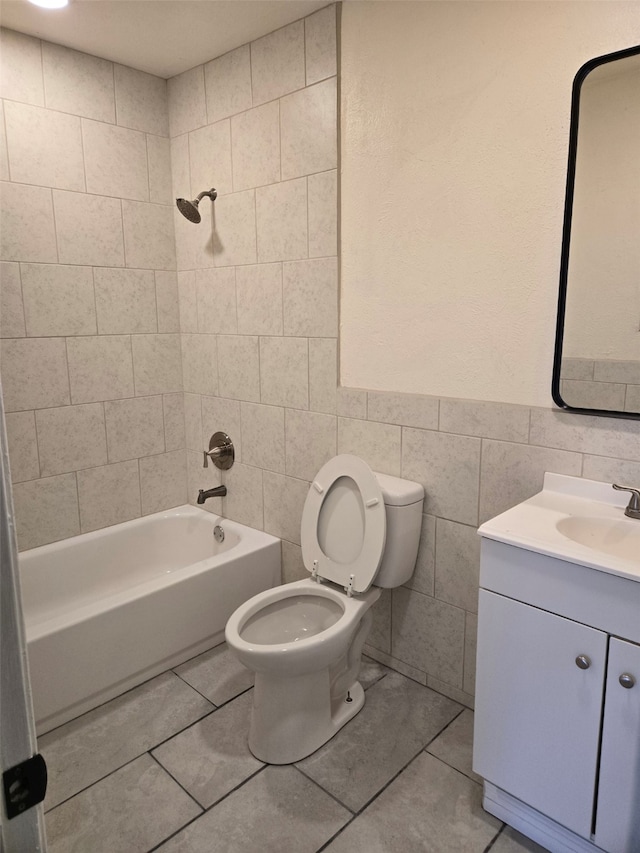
[473,590,607,838]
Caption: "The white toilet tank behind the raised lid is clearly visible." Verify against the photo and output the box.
[373,471,424,589]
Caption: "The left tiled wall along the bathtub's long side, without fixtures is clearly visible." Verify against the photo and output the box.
[0,30,186,549]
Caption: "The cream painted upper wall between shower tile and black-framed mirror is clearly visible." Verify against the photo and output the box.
[340,0,640,406]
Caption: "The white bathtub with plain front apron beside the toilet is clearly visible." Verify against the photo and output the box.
[20,506,281,734]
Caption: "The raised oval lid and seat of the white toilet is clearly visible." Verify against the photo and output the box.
[301,453,387,592]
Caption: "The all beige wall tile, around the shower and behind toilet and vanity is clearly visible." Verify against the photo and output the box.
[0,6,640,705]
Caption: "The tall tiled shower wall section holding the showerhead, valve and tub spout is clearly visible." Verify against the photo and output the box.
[169,6,338,552]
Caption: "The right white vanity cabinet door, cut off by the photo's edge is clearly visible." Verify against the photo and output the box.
[595,639,640,853]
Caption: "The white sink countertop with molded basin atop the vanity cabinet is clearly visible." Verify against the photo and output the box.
[478,473,640,582]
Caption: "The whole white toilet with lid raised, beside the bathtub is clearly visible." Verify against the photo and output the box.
[225,454,424,764]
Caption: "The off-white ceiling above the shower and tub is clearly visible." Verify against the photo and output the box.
[0,0,327,77]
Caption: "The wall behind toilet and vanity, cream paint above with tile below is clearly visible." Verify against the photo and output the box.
[338,2,640,704]
